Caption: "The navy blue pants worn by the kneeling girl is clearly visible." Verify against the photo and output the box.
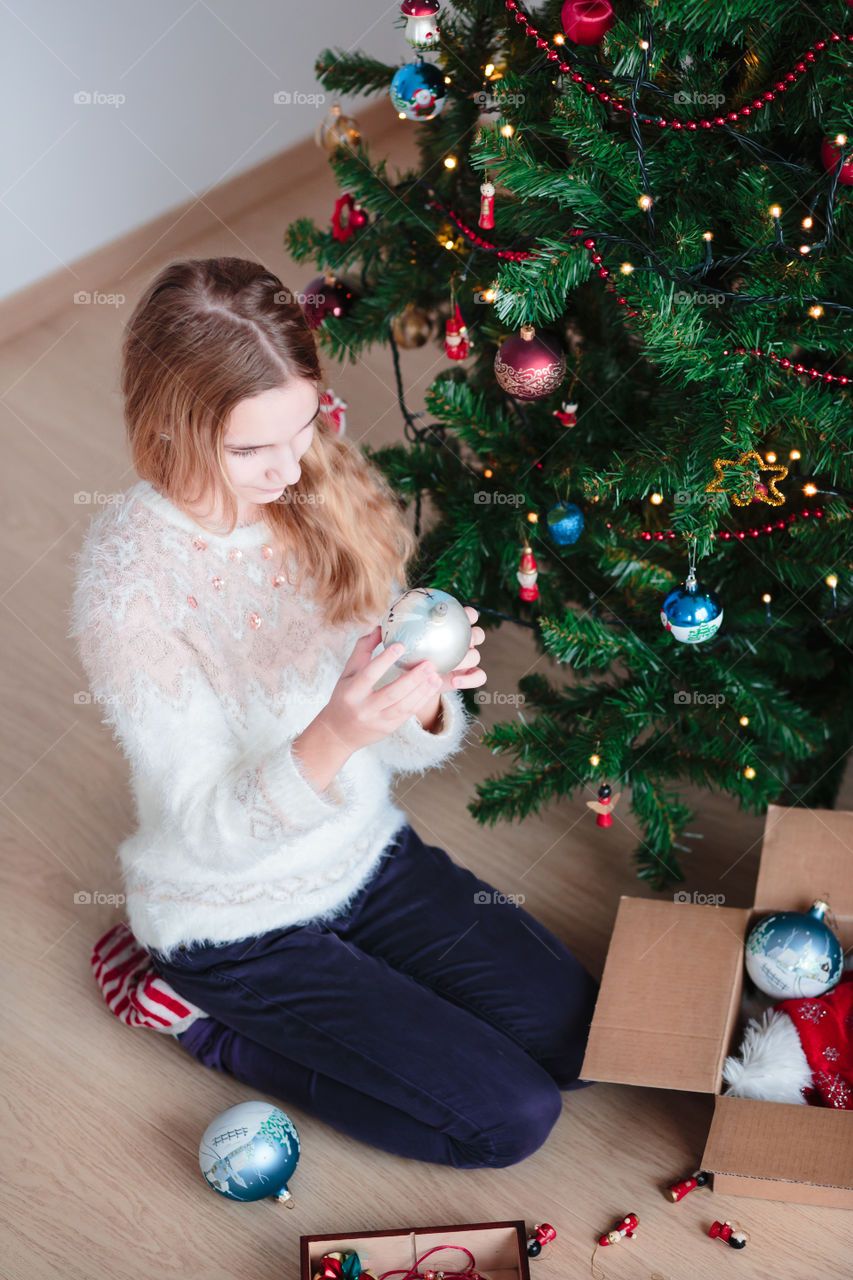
[151,824,597,1169]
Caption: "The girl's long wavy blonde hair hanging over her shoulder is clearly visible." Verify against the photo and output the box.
[122,257,416,625]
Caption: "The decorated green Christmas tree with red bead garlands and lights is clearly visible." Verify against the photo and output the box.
[286,0,853,887]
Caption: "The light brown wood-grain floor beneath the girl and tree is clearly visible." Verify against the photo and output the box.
[0,112,853,1280]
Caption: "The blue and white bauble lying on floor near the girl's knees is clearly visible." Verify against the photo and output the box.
[199,1102,300,1202]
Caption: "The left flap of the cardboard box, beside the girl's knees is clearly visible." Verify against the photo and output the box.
[580,897,749,1093]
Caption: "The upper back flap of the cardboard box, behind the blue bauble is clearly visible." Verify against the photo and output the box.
[756,804,853,916]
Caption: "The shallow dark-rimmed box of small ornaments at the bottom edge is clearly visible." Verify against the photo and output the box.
[300,1221,530,1280]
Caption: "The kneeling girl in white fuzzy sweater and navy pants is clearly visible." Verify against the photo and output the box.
[69,257,596,1167]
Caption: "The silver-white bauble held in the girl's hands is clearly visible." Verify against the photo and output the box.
[373,586,471,689]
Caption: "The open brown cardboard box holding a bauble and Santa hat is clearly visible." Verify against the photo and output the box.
[580,805,853,1208]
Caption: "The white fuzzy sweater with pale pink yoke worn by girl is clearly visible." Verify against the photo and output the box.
[68,480,470,954]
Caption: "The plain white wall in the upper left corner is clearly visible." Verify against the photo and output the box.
[0,0,404,297]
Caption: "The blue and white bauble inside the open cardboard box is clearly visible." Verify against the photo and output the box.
[744,902,844,1000]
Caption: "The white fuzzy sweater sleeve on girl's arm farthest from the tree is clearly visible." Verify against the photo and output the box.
[69,517,355,870]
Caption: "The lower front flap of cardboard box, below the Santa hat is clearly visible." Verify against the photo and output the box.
[702,1097,853,1188]
